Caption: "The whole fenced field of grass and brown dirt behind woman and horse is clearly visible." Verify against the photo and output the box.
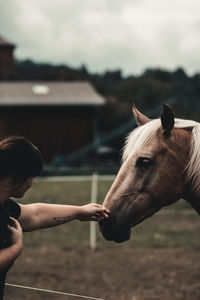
[5,181,200,300]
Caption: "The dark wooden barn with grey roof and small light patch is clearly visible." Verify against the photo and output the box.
[0,81,105,163]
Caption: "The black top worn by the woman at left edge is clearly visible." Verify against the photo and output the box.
[0,199,21,300]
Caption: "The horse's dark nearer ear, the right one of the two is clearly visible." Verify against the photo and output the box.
[160,104,174,136]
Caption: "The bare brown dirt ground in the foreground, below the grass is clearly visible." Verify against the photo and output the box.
[5,248,200,300]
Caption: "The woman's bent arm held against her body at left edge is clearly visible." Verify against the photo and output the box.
[0,218,23,271]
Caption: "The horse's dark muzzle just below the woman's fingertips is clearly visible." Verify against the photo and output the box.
[99,216,131,243]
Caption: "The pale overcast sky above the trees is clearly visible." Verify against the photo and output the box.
[0,0,200,74]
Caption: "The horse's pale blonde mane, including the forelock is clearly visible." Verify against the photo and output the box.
[122,119,200,194]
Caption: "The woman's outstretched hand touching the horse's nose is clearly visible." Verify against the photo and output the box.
[78,203,110,221]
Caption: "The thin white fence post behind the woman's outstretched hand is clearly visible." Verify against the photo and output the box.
[90,173,98,250]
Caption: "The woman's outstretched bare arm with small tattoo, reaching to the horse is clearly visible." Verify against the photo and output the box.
[18,203,109,231]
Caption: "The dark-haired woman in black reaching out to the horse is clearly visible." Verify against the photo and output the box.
[0,136,109,299]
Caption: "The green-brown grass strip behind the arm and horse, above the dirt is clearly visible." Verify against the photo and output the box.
[15,177,200,250]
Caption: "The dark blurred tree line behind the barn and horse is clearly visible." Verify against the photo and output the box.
[15,60,200,132]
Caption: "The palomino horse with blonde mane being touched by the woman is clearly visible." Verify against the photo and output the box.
[99,104,200,243]
